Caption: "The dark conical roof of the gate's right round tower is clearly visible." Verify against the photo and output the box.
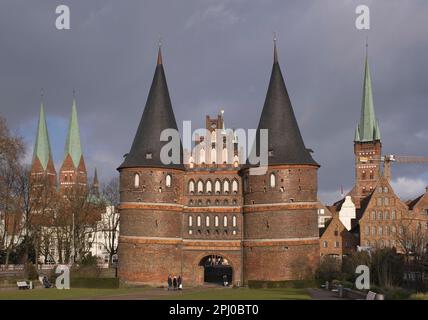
[251,42,318,166]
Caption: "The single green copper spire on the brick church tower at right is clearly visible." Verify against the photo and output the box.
[355,55,380,142]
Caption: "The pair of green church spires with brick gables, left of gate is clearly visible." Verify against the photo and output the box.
[31,95,94,191]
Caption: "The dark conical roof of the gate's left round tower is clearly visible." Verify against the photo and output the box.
[119,48,184,169]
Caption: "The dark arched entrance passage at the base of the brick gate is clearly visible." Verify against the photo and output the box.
[199,255,233,285]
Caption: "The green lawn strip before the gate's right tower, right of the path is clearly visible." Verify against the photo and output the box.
[162,288,311,300]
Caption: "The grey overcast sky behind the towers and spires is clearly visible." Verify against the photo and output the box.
[0,0,428,203]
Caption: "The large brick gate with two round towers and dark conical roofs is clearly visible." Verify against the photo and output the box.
[118,43,319,285]
